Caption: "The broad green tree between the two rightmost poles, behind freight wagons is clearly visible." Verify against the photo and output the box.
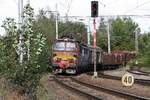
[111,18,138,51]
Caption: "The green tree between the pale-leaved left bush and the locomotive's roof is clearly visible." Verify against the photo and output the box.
[33,10,56,50]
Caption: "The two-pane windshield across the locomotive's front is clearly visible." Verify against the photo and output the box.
[53,42,77,51]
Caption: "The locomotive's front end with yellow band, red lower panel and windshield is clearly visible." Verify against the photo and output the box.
[52,39,79,74]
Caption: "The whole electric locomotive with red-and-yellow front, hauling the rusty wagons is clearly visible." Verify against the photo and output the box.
[52,38,103,74]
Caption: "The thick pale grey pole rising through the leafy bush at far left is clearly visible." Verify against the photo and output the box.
[18,0,23,65]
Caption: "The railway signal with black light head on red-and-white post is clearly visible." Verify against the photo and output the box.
[91,1,98,78]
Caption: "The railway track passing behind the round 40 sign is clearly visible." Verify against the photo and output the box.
[87,73,150,86]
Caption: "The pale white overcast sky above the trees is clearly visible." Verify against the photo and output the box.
[0,0,150,34]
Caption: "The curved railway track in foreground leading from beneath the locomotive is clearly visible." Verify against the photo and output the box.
[53,76,150,100]
